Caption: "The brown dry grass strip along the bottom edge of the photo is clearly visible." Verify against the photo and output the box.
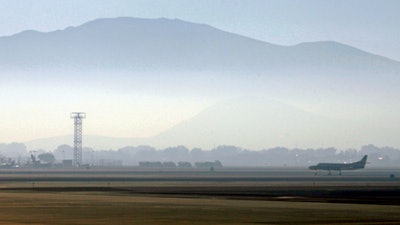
[0,191,400,225]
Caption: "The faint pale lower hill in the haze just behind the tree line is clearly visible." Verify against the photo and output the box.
[26,97,399,150]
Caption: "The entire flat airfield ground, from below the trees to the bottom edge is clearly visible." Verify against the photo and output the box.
[0,168,400,225]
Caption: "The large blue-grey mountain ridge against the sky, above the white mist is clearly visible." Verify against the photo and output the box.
[0,17,400,76]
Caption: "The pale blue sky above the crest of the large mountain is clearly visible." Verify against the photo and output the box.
[0,0,400,60]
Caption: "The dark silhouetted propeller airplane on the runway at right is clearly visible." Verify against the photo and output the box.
[308,155,367,175]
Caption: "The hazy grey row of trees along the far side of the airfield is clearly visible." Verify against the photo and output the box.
[0,143,400,167]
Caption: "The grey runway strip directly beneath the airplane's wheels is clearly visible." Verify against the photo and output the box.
[0,167,400,182]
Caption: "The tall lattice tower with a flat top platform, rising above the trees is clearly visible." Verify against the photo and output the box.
[71,112,86,167]
